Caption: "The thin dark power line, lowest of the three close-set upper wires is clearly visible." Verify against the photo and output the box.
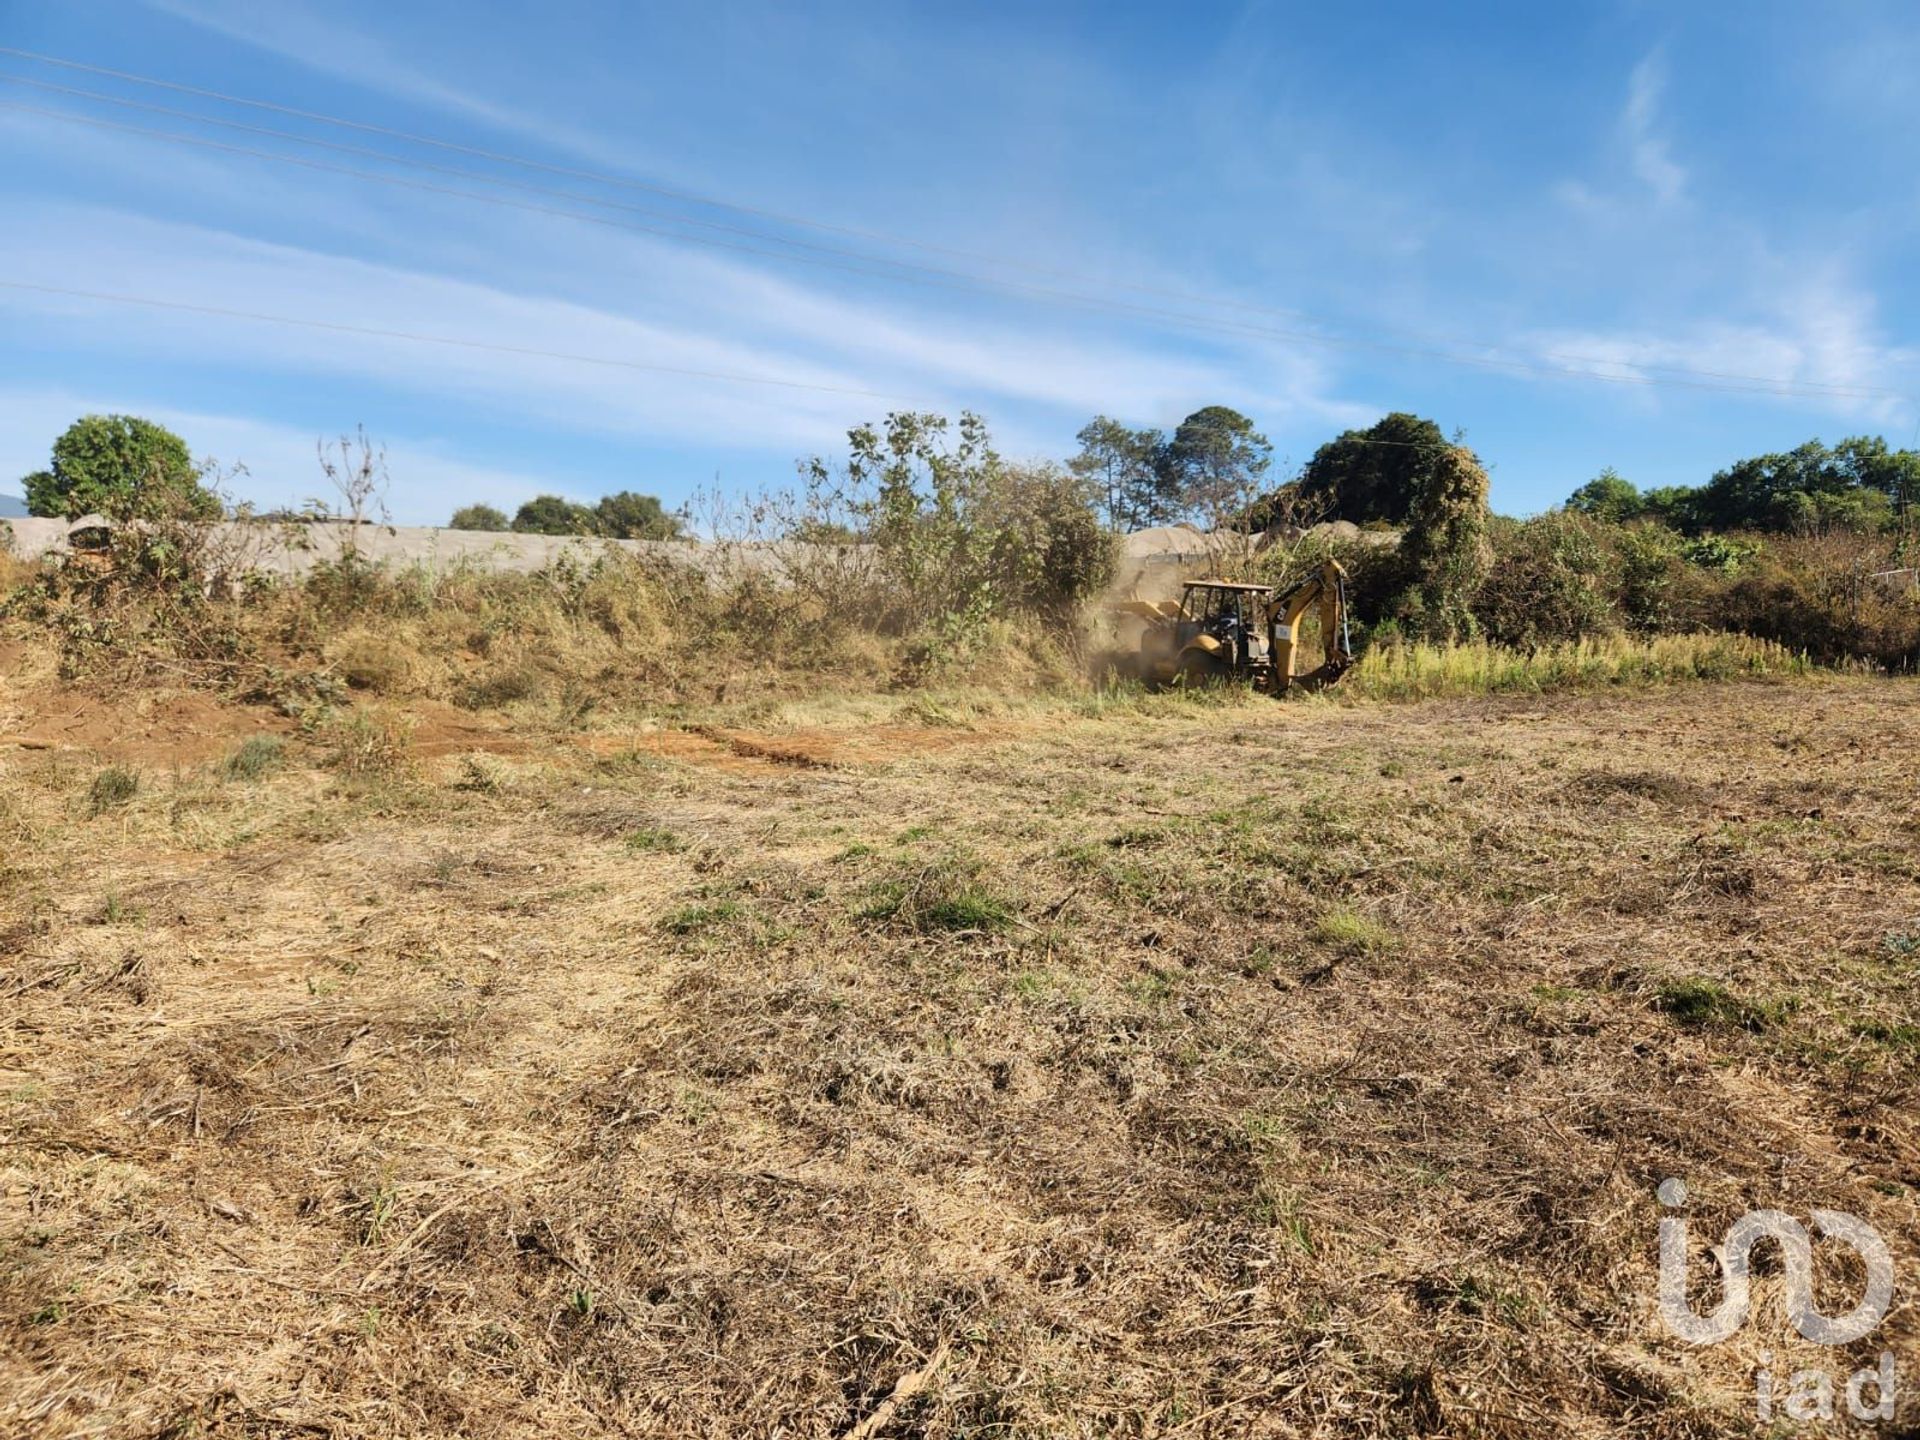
[0,102,1901,399]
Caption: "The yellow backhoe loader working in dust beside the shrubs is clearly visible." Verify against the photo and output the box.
[1114,561,1354,695]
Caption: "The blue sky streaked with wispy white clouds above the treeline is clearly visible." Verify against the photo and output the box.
[0,0,1920,522]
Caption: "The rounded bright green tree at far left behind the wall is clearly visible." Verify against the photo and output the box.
[23,415,221,520]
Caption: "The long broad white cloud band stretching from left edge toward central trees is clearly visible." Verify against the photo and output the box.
[0,183,1359,451]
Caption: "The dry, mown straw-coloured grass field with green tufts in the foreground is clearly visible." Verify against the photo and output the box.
[0,653,1920,1438]
